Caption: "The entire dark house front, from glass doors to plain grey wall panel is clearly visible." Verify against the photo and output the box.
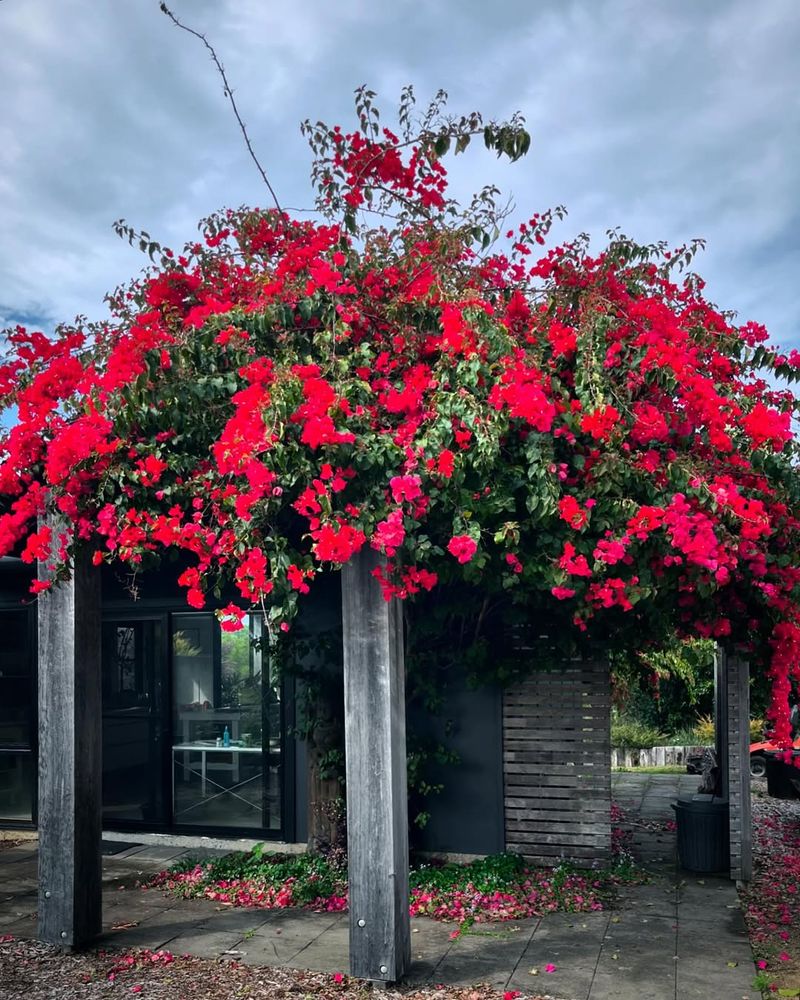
[0,559,505,854]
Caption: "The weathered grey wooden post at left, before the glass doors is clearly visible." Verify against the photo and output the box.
[39,521,102,948]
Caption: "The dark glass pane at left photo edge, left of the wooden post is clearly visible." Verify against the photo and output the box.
[0,609,36,824]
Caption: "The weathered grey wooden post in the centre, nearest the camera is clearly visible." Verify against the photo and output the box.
[342,549,411,982]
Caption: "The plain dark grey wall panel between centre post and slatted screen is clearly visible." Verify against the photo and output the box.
[409,683,505,854]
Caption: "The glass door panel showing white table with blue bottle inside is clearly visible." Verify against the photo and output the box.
[172,613,281,830]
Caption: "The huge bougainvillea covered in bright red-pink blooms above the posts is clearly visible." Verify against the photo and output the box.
[0,90,800,741]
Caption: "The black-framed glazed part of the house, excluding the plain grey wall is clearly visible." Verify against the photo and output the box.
[0,559,305,841]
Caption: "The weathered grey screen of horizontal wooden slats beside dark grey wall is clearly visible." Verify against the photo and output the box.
[503,662,611,864]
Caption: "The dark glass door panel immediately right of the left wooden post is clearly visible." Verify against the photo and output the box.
[103,616,169,826]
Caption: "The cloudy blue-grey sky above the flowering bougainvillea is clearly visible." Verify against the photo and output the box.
[0,0,800,347]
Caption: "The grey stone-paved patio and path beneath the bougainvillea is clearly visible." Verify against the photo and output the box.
[0,773,760,1000]
